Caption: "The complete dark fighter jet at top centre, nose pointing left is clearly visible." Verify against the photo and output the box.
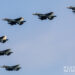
[33,12,56,20]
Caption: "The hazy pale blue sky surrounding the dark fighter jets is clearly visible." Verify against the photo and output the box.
[0,0,75,75]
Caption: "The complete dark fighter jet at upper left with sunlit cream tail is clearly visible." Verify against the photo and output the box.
[3,17,26,25]
